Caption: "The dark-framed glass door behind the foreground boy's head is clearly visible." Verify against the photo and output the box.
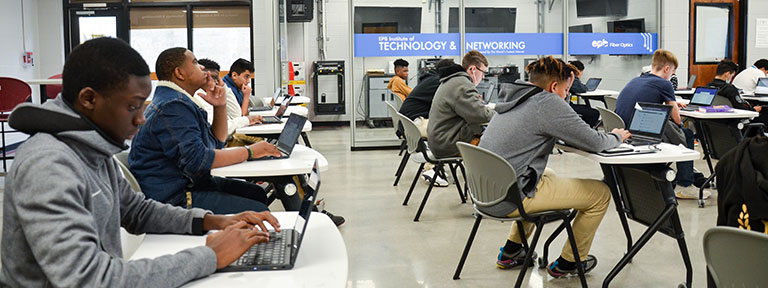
[65,6,128,54]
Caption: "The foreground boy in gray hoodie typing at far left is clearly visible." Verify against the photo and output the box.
[0,38,279,287]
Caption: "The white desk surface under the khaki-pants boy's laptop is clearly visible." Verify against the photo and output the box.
[557,143,701,164]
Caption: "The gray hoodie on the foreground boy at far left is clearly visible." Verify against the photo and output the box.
[0,97,216,287]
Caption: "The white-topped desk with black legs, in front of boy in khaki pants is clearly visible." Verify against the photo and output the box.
[557,143,700,287]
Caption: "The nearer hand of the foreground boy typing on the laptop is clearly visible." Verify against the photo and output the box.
[205,221,269,269]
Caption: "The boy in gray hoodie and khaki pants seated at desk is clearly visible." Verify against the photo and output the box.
[480,56,630,278]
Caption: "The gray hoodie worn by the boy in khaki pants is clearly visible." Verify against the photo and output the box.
[480,81,621,198]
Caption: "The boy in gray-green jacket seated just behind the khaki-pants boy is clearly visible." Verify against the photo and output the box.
[427,50,493,158]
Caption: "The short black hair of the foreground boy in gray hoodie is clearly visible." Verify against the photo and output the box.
[61,37,149,103]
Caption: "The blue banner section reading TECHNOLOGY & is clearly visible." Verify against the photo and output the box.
[355,33,461,57]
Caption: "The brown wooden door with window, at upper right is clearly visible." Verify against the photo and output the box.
[678,0,746,87]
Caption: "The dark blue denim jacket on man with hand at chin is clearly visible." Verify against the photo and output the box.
[128,81,224,205]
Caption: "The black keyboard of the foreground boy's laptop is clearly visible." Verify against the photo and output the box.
[234,229,292,266]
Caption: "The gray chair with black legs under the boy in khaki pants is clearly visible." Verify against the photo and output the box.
[453,142,587,287]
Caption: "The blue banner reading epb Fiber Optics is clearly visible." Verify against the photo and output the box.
[568,33,659,55]
